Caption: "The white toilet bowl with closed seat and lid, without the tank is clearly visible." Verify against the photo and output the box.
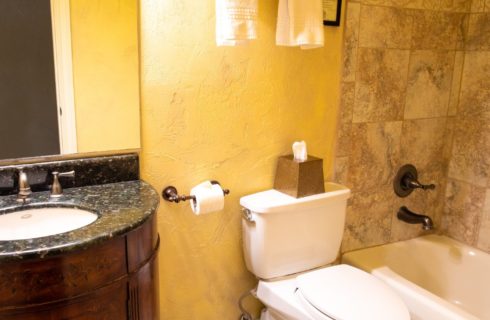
[257,265,410,320]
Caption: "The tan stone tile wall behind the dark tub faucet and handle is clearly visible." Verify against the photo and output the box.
[335,0,478,252]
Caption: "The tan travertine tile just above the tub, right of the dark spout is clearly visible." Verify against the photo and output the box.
[443,180,486,246]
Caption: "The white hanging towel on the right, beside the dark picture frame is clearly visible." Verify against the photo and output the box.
[276,0,324,49]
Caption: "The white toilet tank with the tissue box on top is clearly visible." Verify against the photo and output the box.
[240,183,350,279]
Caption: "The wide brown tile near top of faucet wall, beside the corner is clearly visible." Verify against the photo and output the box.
[412,10,467,50]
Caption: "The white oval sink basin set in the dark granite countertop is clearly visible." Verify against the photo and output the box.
[0,208,98,241]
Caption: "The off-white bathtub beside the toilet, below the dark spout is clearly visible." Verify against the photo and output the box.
[342,235,490,320]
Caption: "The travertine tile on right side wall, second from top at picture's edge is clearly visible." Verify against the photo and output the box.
[458,51,490,119]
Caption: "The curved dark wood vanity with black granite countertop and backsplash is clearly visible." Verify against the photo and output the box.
[0,154,160,320]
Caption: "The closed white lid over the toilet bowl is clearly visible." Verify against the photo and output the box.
[296,264,410,320]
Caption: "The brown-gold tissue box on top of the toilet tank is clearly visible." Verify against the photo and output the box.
[274,155,325,198]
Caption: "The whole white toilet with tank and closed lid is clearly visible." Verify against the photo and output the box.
[240,183,410,320]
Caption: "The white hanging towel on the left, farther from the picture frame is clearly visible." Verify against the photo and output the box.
[216,0,258,46]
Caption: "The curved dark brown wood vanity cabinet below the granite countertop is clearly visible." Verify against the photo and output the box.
[0,215,159,320]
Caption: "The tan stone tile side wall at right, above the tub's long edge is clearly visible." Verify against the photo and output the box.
[442,0,490,252]
